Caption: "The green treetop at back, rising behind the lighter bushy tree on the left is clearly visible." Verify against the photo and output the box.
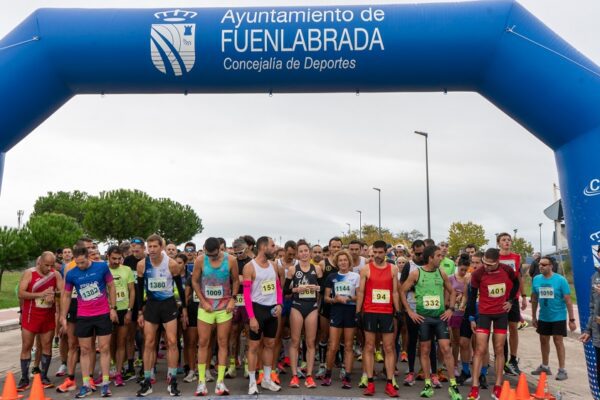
[32,190,89,224]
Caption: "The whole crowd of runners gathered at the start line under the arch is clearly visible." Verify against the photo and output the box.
[18,233,575,400]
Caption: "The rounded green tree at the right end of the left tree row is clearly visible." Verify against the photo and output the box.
[156,199,203,243]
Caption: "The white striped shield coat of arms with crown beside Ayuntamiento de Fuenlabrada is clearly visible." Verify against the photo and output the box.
[150,10,198,76]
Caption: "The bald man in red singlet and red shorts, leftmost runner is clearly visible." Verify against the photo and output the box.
[18,251,63,391]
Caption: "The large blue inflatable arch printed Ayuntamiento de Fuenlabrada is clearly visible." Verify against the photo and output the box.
[0,1,600,399]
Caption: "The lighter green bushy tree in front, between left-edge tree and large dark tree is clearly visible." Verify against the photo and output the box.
[24,213,83,258]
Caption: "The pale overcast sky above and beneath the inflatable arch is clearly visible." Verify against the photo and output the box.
[0,0,600,251]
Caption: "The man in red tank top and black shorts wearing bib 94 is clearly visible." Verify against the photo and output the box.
[356,240,400,397]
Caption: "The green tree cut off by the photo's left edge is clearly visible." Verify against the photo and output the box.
[0,226,30,287]
